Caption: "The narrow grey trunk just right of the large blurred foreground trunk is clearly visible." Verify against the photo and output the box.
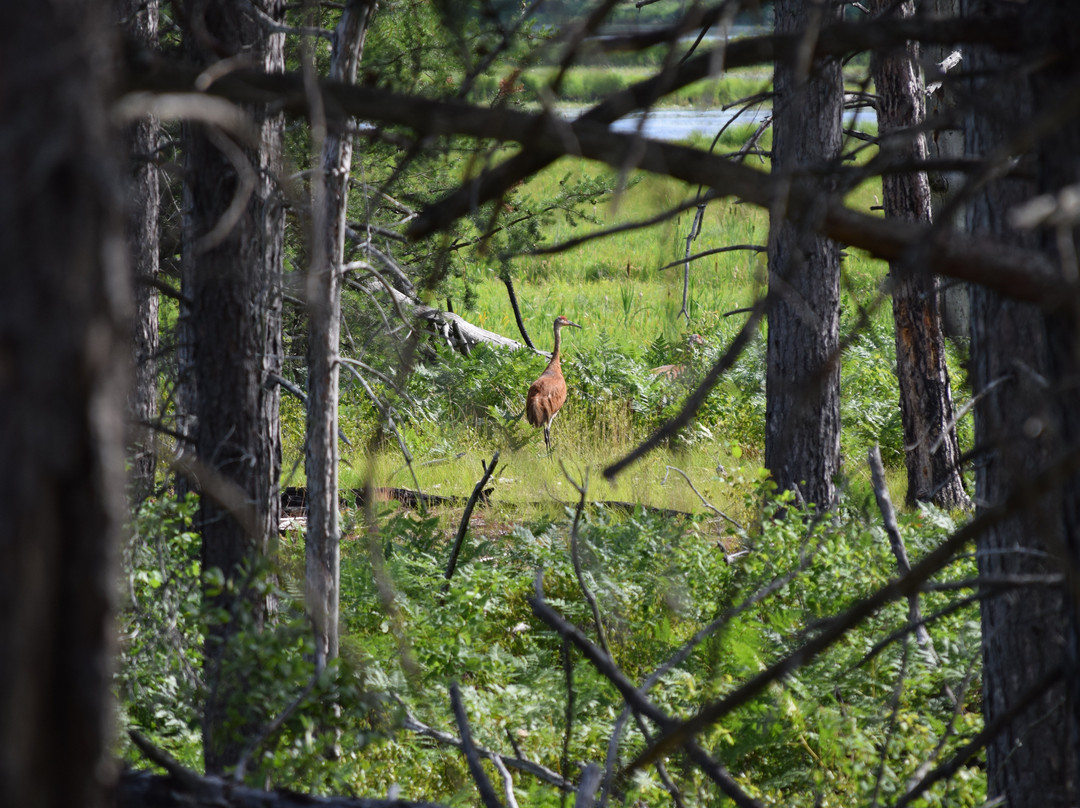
[117,0,160,502]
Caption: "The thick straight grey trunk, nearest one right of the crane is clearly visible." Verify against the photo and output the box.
[765,0,843,508]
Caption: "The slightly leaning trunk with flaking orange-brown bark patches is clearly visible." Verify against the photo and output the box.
[872,0,970,508]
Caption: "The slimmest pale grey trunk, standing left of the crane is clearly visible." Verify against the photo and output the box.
[305,0,375,666]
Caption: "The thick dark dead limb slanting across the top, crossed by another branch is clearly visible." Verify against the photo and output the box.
[128,46,1070,308]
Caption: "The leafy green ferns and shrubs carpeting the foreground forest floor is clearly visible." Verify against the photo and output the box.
[117,483,985,806]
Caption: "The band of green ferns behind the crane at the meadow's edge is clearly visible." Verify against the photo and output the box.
[365,306,904,466]
